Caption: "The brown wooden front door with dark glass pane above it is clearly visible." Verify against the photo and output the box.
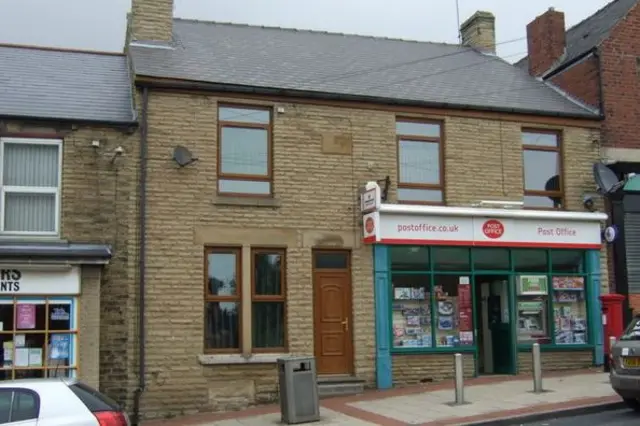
[313,250,353,374]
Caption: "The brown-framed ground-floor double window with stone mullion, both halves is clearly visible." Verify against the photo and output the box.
[204,247,287,353]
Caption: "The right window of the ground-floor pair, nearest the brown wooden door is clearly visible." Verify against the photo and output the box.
[251,249,286,351]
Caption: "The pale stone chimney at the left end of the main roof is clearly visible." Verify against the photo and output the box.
[129,0,174,42]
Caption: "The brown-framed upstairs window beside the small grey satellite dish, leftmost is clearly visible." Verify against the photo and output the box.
[217,105,273,196]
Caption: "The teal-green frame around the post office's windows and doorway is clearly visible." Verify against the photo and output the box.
[374,245,602,388]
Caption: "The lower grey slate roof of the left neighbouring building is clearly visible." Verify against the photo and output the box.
[0,45,135,124]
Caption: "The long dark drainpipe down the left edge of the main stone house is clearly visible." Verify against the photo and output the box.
[133,87,149,425]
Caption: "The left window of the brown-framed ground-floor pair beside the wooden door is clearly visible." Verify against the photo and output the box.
[204,248,242,352]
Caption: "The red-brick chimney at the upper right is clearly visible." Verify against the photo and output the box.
[527,7,566,77]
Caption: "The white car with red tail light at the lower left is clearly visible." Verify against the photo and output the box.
[0,378,130,426]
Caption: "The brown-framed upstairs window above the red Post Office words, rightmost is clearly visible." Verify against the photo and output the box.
[522,129,563,209]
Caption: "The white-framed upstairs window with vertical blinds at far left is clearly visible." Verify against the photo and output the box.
[0,138,62,236]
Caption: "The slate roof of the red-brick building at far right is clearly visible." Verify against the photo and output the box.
[515,0,638,74]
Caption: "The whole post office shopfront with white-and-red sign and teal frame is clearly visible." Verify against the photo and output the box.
[363,186,606,388]
